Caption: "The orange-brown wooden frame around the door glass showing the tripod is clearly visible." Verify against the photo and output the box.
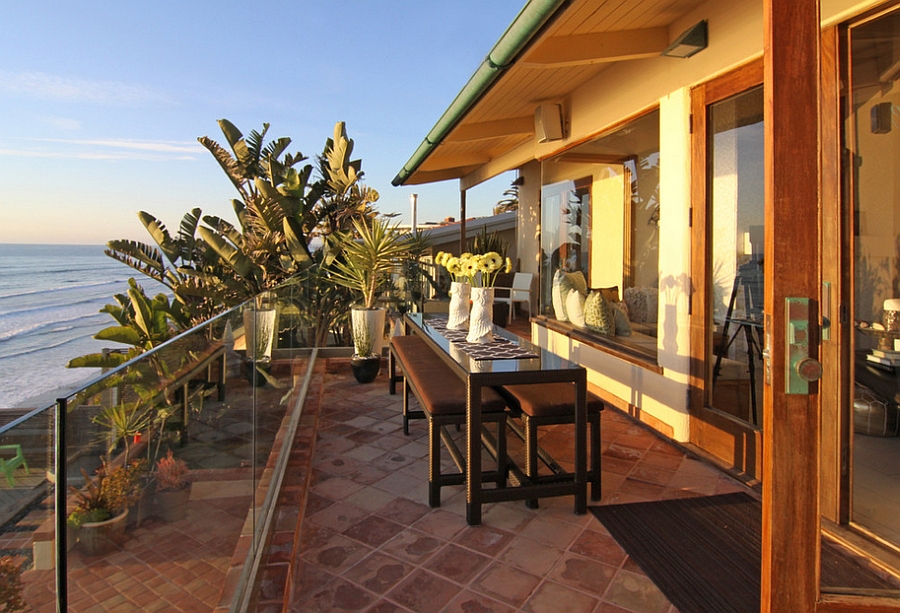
[690,58,763,477]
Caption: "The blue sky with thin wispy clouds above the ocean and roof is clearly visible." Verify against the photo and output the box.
[0,0,525,244]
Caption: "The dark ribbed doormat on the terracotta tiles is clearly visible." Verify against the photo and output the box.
[590,492,896,613]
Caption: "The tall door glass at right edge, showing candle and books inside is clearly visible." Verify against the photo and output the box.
[846,11,900,546]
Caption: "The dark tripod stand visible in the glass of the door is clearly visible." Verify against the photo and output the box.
[713,260,763,425]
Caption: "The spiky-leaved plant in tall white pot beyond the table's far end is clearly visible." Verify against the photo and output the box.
[332,218,407,382]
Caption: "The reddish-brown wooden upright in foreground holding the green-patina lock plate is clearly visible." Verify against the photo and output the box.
[760,0,820,613]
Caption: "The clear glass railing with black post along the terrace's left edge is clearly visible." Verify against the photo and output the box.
[0,274,326,612]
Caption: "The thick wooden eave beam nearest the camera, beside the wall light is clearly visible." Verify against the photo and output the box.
[521,28,669,68]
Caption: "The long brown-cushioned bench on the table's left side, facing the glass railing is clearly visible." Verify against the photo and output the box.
[389,335,508,507]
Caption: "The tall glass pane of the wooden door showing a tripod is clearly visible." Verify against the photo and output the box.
[708,87,765,425]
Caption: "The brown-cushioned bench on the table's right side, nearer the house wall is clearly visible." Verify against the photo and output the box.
[497,383,604,508]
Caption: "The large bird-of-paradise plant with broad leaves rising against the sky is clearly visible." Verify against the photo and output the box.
[91,119,378,360]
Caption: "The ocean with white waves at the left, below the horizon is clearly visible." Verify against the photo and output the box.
[0,244,143,409]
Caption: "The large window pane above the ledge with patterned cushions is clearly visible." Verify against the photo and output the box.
[541,111,660,361]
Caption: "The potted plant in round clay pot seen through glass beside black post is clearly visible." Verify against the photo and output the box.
[67,460,145,555]
